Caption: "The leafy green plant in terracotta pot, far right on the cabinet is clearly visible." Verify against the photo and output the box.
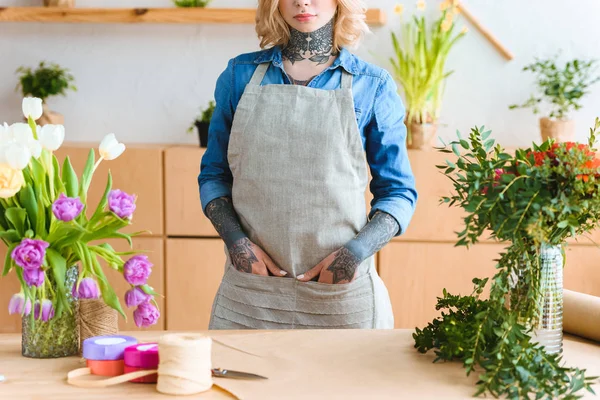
[509,57,600,142]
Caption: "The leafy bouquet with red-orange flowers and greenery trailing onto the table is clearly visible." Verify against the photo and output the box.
[413,119,600,399]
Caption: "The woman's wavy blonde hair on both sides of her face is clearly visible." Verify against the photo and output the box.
[256,0,370,53]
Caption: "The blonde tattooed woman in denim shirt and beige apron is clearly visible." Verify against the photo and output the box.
[198,0,417,329]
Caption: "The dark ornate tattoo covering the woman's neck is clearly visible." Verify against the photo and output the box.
[281,18,337,65]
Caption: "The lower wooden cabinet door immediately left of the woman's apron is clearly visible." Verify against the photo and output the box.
[166,239,225,330]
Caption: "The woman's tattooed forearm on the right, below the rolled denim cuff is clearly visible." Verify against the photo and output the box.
[345,211,400,261]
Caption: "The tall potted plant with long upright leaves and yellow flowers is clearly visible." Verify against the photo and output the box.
[390,0,467,149]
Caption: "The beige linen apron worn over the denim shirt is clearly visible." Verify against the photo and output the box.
[209,63,394,329]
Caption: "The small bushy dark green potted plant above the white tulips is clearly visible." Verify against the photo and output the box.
[15,61,77,126]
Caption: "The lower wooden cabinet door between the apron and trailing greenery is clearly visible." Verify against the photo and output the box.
[379,242,504,329]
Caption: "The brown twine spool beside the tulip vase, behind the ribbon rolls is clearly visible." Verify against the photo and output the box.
[79,299,119,352]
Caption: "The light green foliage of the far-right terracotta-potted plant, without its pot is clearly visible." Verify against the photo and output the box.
[509,57,600,119]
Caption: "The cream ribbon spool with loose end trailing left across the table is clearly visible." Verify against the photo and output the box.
[67,334,213,395]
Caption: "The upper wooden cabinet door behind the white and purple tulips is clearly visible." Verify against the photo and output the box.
[56,144,164,235]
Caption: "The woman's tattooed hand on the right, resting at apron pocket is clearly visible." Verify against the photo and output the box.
[296,247,360,284]
